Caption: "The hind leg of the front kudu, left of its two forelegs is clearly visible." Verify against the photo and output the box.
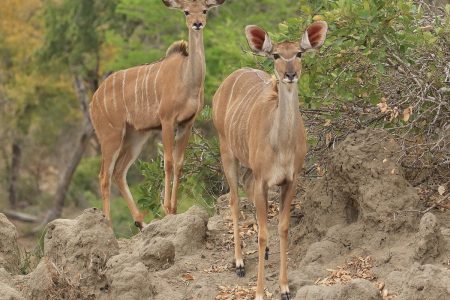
[220,141,245,277]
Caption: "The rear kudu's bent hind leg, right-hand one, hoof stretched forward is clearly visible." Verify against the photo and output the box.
[113,132,149,229]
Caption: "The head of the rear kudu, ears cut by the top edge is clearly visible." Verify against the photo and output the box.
[163,0,225,31]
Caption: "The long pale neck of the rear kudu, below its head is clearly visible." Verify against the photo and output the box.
[185,29,206,87]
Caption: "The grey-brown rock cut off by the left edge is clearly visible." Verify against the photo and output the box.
[0,213,20,274]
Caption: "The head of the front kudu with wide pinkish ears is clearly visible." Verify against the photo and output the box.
[245,21,328,84]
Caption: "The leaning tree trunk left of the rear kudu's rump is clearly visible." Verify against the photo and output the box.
[42,75,93,225]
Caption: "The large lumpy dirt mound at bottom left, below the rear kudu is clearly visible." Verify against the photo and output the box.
[23,208,119,299]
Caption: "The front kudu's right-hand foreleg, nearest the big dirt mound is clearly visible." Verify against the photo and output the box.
[278,178,296,300]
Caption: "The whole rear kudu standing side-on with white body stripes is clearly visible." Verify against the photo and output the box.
[90,0,225,229]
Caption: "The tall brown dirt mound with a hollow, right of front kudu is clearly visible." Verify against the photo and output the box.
[291,130,450,299]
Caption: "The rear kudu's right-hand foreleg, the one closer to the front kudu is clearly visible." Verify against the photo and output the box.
[170,122,194,214]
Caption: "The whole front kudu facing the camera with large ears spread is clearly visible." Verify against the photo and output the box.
[213,21,328,300]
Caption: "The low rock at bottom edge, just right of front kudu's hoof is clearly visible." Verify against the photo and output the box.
[294,279,383,300]
